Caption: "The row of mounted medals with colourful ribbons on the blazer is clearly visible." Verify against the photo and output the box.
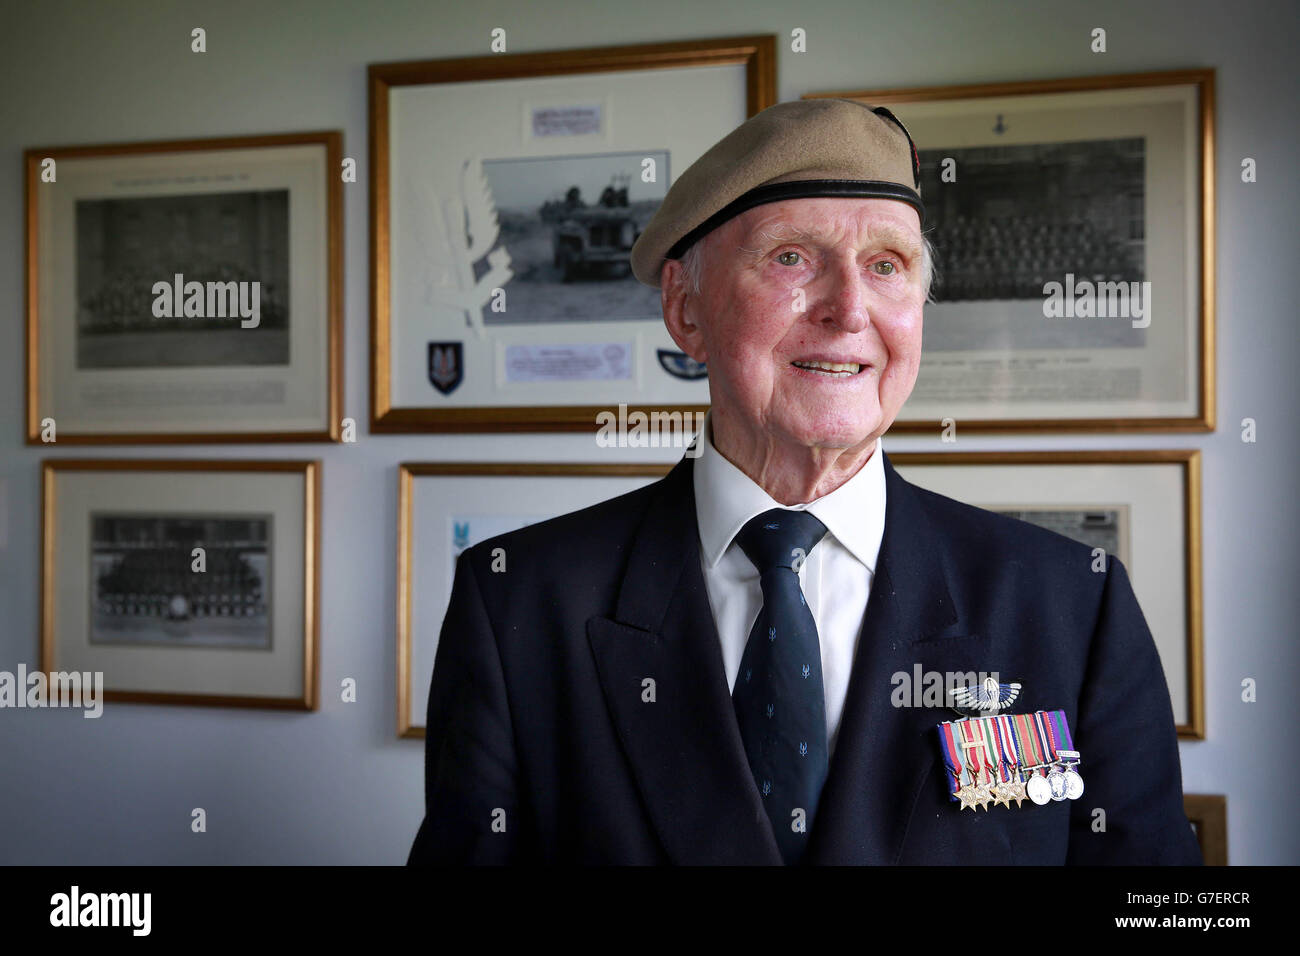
[936,710,1083,810]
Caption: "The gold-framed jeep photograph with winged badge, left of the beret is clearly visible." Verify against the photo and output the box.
[369,36,776,432]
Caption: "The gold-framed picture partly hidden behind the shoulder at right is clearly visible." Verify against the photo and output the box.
[889,449,1205,740]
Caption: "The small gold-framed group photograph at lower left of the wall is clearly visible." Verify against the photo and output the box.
[40,459,320,710]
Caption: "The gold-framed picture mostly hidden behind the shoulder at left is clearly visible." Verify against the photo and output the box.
[397,462,672,737]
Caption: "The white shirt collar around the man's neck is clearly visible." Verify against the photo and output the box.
[694,412,885,574]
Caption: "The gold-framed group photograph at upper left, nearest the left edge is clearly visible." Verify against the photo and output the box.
[26,133,343,445]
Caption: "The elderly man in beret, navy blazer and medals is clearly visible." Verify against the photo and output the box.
[411,100,1200,865]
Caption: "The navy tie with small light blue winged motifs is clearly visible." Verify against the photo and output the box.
[732,509,828,864]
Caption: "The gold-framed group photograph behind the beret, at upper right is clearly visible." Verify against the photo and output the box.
[810,70,1214,432]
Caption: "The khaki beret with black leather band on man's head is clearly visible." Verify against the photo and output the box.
[632,98,926,287]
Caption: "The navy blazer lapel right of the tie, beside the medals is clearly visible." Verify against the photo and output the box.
[807,450,965,864]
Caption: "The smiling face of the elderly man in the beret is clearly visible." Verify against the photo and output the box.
[664,198,924,449]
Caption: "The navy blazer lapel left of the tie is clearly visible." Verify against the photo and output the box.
[588,458,780,865]
